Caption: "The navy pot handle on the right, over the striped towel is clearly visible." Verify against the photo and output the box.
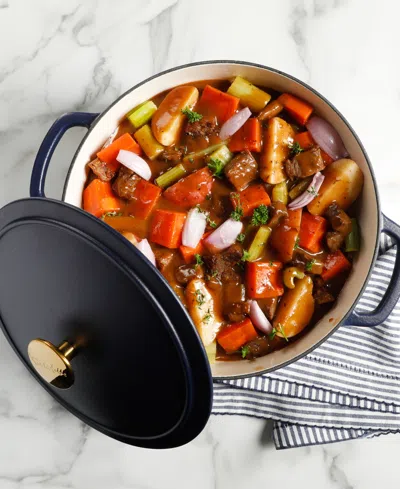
[343,214,400,326]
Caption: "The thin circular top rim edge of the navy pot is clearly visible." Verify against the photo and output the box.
[61,60,382,380]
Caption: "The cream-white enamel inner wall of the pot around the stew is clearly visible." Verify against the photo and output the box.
[64,62,379,377]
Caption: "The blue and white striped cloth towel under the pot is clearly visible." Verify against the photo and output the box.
[213,235,400,449]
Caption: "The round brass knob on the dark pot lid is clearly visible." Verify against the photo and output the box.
[28,338,76,389]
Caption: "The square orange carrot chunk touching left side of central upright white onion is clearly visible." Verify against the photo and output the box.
[150,209,186,248]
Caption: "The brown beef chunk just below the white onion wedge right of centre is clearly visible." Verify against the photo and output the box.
[203,245,243,283]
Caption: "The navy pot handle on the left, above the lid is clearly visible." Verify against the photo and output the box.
[30,112,99,197]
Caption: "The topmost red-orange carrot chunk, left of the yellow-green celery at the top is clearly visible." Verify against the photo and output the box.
[196,85,240,124]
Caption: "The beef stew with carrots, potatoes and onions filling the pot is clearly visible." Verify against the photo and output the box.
[83,77,363,362]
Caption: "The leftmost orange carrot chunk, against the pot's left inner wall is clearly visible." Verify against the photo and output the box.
[83,179,121,217]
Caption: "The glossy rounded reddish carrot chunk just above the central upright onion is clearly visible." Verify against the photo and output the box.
[164,168,213,206]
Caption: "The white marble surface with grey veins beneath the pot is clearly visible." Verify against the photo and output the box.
[0,0,400,489]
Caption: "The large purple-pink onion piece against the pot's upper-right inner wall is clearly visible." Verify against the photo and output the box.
[306,115,349,160]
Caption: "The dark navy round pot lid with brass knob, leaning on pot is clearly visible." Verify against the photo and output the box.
[0,199,212,448]
